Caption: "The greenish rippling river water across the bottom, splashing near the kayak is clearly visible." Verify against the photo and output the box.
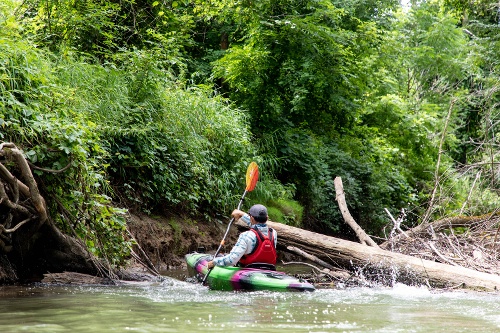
[0,278,500,333]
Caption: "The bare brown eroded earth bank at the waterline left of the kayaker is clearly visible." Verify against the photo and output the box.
[41,214,232,285]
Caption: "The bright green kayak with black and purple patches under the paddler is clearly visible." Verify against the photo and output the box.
[185,253,315,291]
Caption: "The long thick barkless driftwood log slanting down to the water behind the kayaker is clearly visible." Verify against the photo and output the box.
[236,221,500,291]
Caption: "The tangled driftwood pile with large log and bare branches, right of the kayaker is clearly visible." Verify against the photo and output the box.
[268,178,500,292]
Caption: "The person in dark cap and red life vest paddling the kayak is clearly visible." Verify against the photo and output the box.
[207,204,278,269]
